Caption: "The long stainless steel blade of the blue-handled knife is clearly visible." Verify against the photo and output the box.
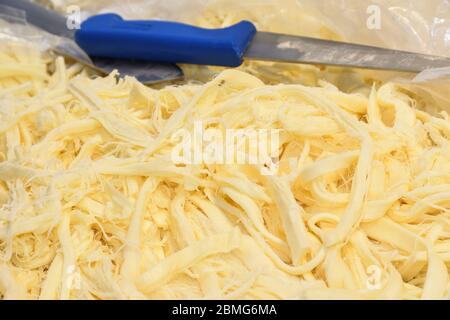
[245,32,450,72]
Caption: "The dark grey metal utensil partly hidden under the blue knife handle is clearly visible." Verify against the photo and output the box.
[0,0,183,84]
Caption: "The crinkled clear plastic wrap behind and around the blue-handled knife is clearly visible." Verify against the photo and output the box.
[40,0,450,112]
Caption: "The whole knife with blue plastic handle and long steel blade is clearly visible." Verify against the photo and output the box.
[0,0,450,72]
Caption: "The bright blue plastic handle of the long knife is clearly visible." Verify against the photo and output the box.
[75,13,256,67]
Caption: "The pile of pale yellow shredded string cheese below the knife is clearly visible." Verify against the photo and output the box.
[0,40,450,299]
